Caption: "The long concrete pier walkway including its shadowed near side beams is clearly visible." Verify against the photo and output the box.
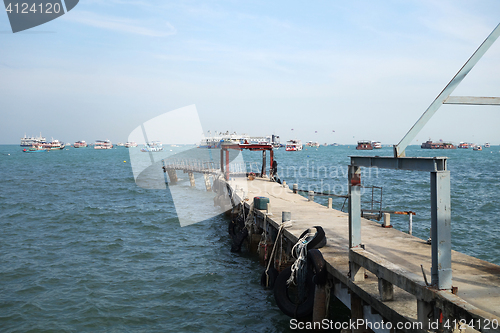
[245,178,500,332]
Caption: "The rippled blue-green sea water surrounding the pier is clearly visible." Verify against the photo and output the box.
[0,145,500,332]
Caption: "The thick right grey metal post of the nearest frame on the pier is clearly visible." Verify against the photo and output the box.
[431,171,452,289]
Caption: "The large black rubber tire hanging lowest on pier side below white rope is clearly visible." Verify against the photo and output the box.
[274,266,315,319]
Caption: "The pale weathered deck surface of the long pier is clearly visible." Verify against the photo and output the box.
[239,178,500,331]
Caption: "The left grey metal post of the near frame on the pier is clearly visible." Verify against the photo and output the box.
[348,165,361,248]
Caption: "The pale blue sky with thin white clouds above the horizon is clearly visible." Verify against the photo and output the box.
[0,0,500,144]
